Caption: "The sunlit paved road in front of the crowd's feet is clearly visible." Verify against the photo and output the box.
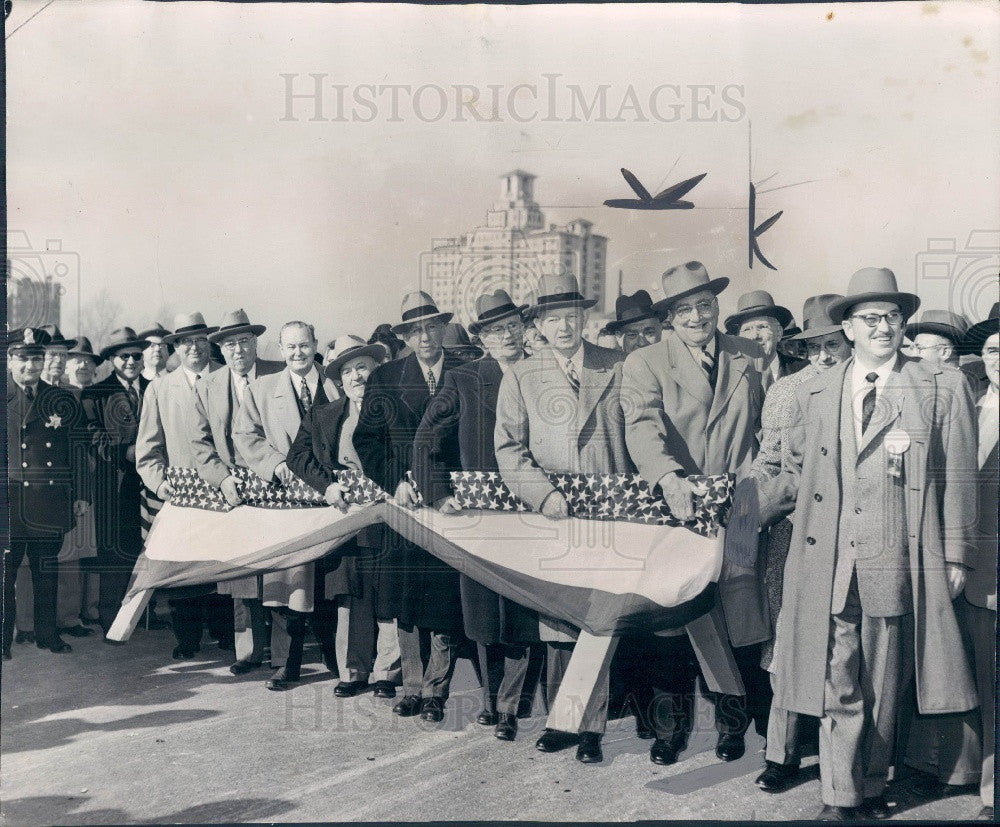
[0,630,979,827]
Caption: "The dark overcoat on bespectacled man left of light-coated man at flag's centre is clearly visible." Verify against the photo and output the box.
[413,355,538,644]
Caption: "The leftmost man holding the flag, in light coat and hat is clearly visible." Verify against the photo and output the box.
[135,313,224,660]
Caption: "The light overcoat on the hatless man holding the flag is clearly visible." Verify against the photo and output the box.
[233,367,339,612]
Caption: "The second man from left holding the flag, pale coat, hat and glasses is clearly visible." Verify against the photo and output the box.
[192,308,284,675]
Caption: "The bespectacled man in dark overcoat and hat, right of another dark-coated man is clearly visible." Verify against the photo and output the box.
[413,290,538,741]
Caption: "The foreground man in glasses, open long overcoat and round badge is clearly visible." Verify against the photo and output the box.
[760,267,977,820]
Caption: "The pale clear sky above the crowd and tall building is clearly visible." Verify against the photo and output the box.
[6,0,1000,350]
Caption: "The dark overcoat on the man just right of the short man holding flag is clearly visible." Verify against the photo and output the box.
[354,351,463,634]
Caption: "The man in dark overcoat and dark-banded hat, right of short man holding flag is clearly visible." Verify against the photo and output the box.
[354,291,462,721]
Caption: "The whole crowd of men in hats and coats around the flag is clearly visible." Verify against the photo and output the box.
[3,262,1000,820]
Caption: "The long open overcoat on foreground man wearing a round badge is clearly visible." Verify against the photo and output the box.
[760,357,977,716]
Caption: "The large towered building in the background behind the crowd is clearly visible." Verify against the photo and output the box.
[420,169,608,324]
